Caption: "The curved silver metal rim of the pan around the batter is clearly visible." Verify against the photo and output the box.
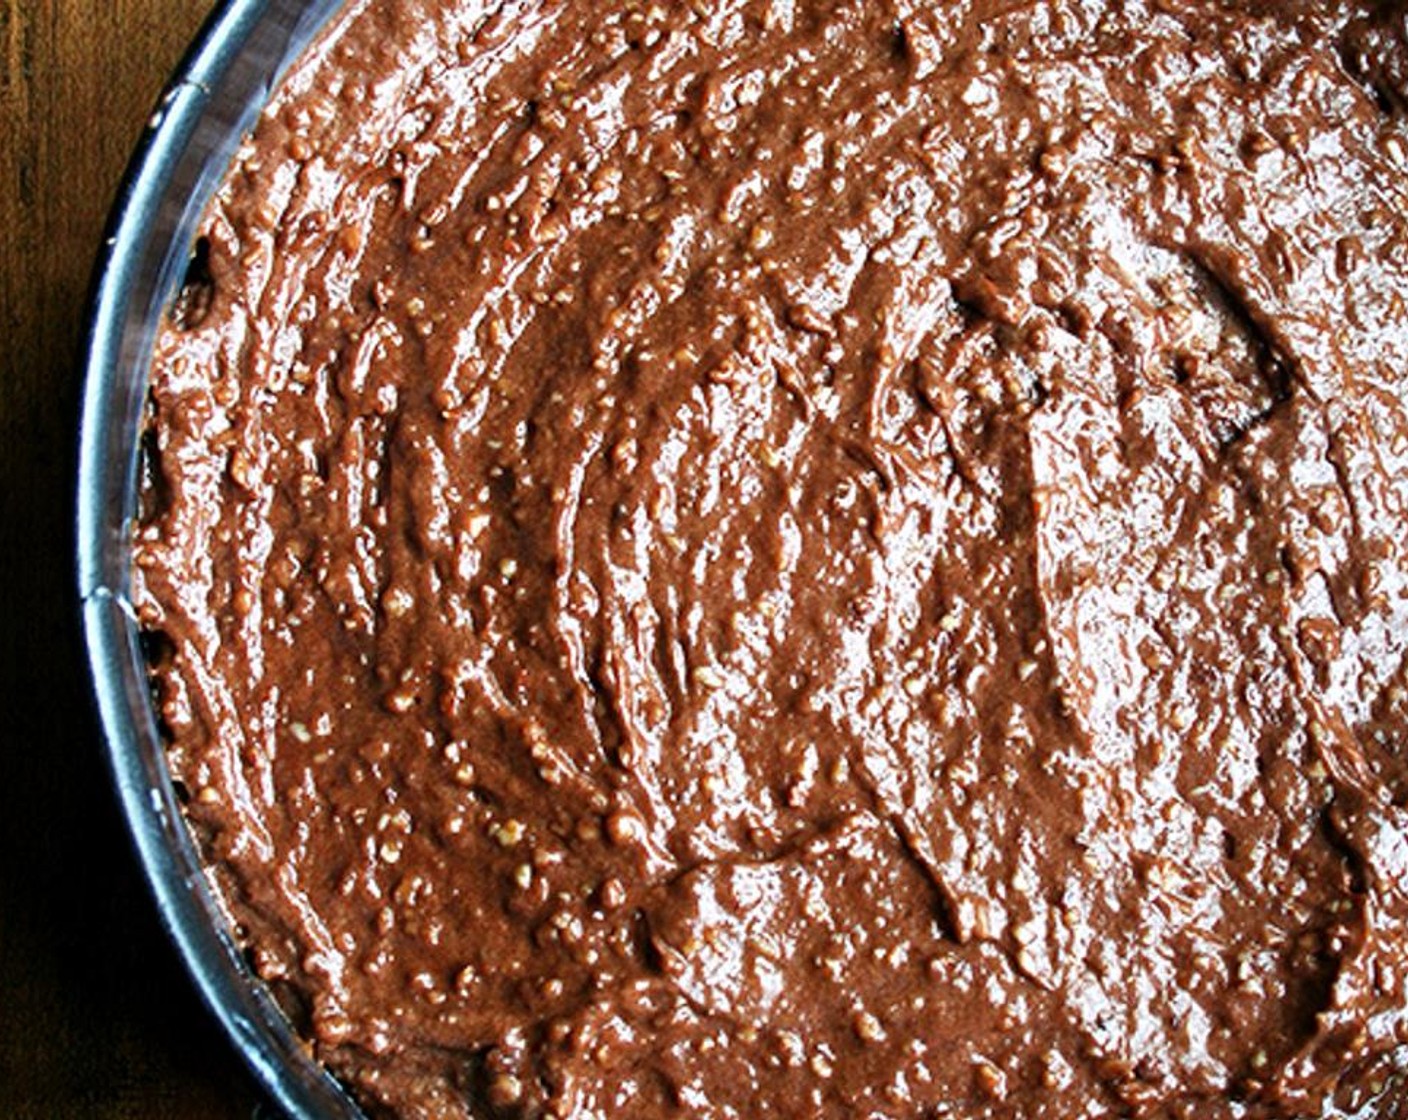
[77,0,362,1120]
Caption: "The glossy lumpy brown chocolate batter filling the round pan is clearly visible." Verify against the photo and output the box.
[135,0,1408,1120]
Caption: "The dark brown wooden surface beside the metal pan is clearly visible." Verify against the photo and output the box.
[0,0,272,1120]
